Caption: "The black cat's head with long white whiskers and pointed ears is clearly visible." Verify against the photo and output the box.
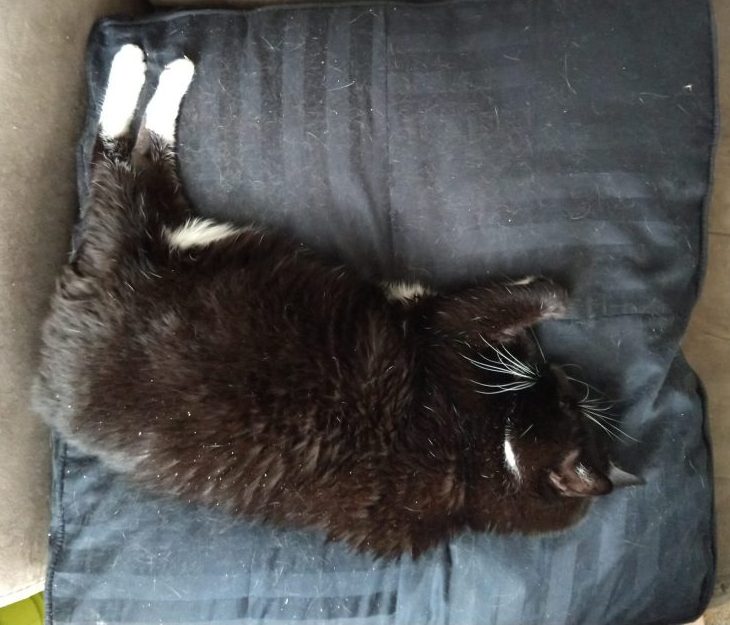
[462,334,642,533]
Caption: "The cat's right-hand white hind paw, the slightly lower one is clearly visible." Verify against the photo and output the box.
[144,57,195,143]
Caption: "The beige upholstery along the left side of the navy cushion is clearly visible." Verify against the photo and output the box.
[0,0,148,606]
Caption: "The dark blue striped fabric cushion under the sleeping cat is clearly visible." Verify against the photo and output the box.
[47,0,715,625]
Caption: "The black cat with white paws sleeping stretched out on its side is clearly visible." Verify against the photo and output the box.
[34,45,636,555]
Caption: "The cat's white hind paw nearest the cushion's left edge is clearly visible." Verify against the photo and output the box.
[99,43,147,139]
